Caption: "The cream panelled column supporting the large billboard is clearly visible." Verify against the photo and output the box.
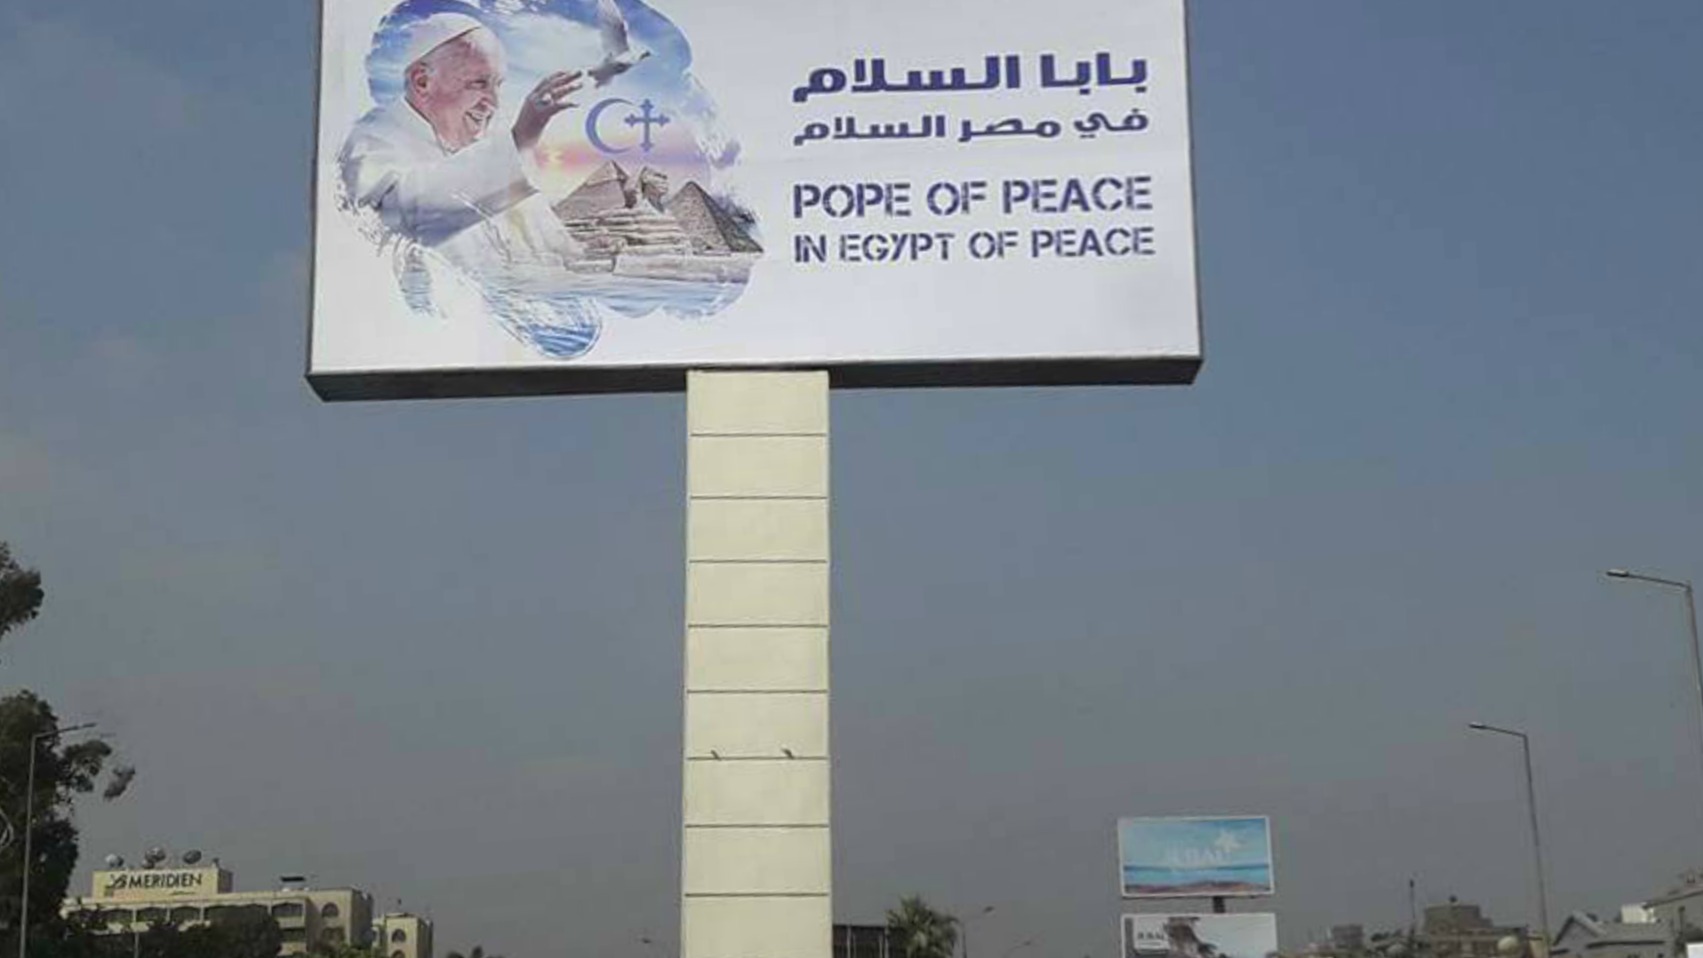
[679,373,833,958]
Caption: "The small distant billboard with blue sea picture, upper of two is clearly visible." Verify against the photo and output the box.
[1117,815,1277,898]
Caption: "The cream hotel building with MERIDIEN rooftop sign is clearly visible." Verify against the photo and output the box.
[63,861,415,958]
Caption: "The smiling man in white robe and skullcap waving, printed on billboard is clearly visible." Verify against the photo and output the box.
[337,12,582,269]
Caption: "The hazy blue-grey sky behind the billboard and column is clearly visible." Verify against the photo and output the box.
[0,0,1703,958]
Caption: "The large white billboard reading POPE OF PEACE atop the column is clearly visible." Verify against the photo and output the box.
[308,0,1201,398]
